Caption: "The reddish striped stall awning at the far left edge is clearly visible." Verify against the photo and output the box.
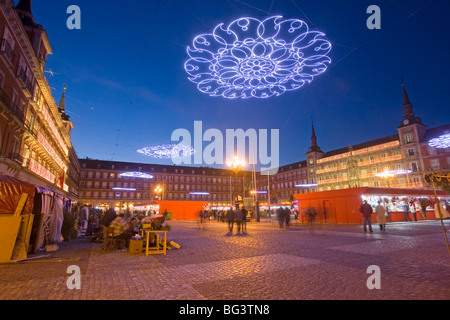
[0,175,35,214]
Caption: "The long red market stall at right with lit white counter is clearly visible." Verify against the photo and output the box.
[294,187,450,224]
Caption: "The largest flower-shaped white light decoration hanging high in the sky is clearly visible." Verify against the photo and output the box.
[184,16,332,99]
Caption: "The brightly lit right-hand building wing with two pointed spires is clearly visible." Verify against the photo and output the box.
[307,86,450,191]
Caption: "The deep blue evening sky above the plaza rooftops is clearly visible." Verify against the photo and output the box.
[25,0,450,167]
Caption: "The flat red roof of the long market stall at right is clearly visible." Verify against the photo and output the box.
[294,187,450,200]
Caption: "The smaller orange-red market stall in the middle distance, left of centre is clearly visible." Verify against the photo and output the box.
[134,200,207,220]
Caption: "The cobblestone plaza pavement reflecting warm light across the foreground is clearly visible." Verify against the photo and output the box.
[0,220,450,300]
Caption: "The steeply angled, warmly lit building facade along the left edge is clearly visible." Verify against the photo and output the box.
[0,0,80,198]
